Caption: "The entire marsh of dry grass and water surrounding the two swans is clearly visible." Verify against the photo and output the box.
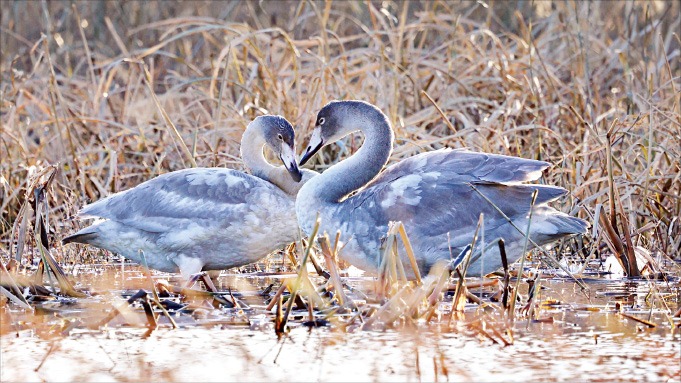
[0,1,681,382]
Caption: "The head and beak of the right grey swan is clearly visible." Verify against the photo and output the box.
[298,100,387,166]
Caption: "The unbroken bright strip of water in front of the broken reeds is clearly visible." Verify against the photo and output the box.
[2,328,679,381]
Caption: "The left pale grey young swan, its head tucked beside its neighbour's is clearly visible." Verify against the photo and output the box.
[62,115,316,279]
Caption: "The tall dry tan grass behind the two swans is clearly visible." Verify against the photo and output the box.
[0,1,681,270]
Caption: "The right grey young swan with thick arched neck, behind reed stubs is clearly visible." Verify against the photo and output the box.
[296,101,587,276]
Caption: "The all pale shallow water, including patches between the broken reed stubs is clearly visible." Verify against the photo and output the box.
[0,270,681,382]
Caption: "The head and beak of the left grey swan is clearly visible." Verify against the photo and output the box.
[249,115,303,182]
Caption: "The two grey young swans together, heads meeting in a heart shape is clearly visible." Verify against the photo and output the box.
[63,101,588,277]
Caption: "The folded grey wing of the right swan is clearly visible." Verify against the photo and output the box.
[346,150,567,236]
